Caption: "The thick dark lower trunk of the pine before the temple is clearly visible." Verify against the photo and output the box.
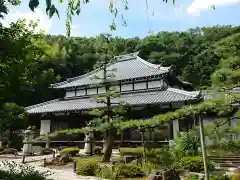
[102,129,116,162]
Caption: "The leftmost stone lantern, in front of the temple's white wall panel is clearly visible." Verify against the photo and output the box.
[23,126,34,155]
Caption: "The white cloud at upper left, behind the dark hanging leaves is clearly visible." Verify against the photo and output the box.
[3,9,52,33]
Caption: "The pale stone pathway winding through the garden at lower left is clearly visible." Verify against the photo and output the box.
[0,155,100,180]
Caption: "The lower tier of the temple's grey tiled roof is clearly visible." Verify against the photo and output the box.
[25,88,200,114]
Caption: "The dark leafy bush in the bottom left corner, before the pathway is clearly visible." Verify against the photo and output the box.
[0,161,51,180]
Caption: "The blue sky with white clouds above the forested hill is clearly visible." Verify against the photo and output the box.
[3,0,240,37]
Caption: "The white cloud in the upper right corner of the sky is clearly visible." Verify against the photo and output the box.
[187,0,240,15]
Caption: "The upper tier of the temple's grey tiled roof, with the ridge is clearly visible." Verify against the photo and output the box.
[52,53,170,88]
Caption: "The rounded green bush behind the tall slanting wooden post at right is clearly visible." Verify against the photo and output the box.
[179,156,214,172]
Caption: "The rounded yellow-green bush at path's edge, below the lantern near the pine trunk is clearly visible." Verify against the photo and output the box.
[76,161,100,176]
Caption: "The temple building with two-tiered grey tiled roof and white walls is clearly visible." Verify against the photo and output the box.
[25,53,203,141]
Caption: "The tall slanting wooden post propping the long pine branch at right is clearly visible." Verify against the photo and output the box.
[199,116,209,180]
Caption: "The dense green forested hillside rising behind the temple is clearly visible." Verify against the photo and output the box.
[0,22,240,111]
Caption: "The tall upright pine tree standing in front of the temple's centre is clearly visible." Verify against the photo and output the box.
[90,35,126,162]
